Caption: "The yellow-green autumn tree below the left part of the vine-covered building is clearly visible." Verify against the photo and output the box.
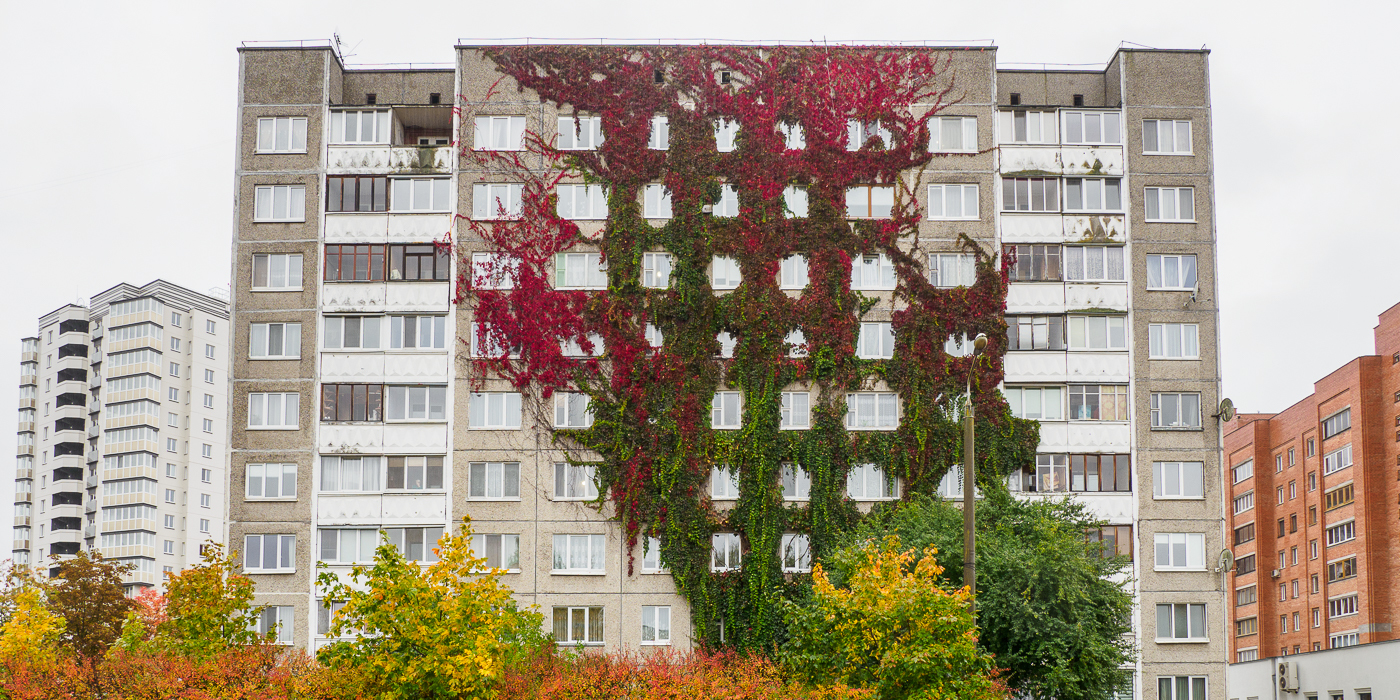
[318,519,547,700]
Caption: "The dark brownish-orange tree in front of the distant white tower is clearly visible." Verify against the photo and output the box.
[48,552,132,657]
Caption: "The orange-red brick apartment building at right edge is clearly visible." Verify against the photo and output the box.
[1225,305,1400,662]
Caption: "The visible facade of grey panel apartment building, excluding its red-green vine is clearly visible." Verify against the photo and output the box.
[230,45,1226,700]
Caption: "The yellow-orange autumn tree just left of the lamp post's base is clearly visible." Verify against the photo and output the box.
[778,536,1005,700]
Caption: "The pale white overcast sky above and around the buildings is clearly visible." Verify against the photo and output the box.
[0,0,1400,546]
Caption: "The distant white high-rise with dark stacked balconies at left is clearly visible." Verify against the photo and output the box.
[14,280,228,589]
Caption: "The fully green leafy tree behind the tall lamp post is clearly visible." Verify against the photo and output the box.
[851,489,1135,700]
